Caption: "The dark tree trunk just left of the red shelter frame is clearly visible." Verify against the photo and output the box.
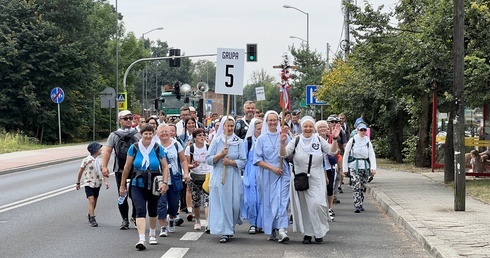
[415,94,431,167]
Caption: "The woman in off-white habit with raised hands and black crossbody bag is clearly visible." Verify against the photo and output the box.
[280,116,341,244]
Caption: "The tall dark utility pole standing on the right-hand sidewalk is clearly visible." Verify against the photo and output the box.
[453,0,466,211]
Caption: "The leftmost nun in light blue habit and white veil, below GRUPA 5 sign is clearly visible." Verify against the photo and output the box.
[206,116,246,243]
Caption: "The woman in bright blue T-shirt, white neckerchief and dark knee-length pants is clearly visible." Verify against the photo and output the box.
[119,124,169,250]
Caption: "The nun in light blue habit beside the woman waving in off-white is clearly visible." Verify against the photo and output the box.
[254,111,290,243]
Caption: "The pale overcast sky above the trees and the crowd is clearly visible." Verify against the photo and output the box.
[109,0,398,84]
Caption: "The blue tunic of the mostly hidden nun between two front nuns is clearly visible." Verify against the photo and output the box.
[242,139,262,228]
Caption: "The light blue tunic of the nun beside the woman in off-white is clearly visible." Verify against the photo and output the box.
[253,133,291,235]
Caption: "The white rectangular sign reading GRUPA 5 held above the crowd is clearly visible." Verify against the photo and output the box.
[215,48,245,95]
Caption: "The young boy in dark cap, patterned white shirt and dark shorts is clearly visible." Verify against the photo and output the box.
[76,142,109,227]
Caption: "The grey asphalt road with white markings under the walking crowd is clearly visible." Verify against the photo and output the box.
[0,161,430,258]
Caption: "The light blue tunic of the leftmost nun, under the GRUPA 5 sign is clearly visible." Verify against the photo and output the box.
[206,138,246,235]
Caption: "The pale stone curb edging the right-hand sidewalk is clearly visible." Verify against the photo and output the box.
[366,185,460,258]
